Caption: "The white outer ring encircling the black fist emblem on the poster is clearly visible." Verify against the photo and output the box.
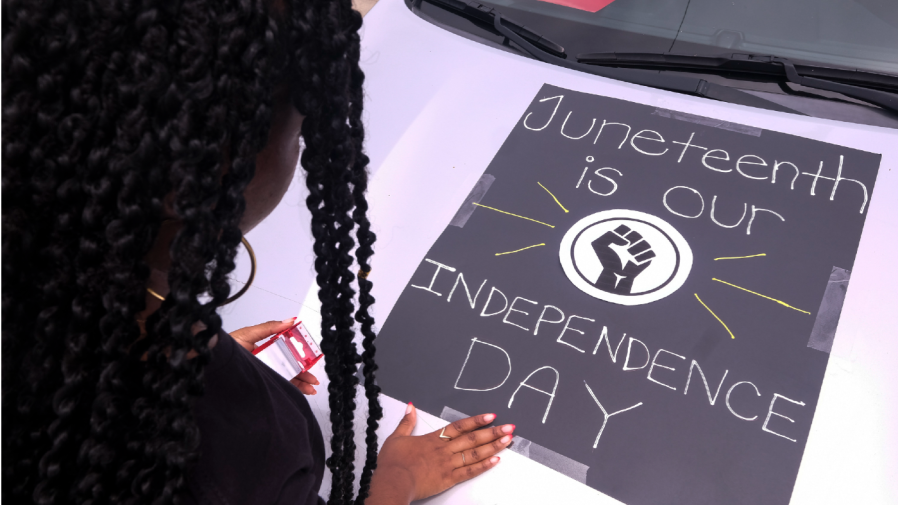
[558,209,692,306]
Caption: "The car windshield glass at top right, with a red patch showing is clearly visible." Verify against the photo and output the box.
[458,0,898,75]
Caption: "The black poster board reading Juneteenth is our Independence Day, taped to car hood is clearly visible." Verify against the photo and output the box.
[378,85,880,505]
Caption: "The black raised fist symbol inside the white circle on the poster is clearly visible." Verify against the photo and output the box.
[592,224,655,295]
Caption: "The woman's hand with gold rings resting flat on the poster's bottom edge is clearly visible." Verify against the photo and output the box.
[366,403,514,505]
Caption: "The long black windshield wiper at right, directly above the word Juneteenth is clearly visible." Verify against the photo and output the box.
[577,53,898,112]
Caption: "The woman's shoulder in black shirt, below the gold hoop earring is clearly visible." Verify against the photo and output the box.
[190,333,324,504]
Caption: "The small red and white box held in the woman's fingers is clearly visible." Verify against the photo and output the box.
[253,321,323,380]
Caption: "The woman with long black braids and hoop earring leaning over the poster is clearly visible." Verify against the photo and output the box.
[0,0,513,505]
